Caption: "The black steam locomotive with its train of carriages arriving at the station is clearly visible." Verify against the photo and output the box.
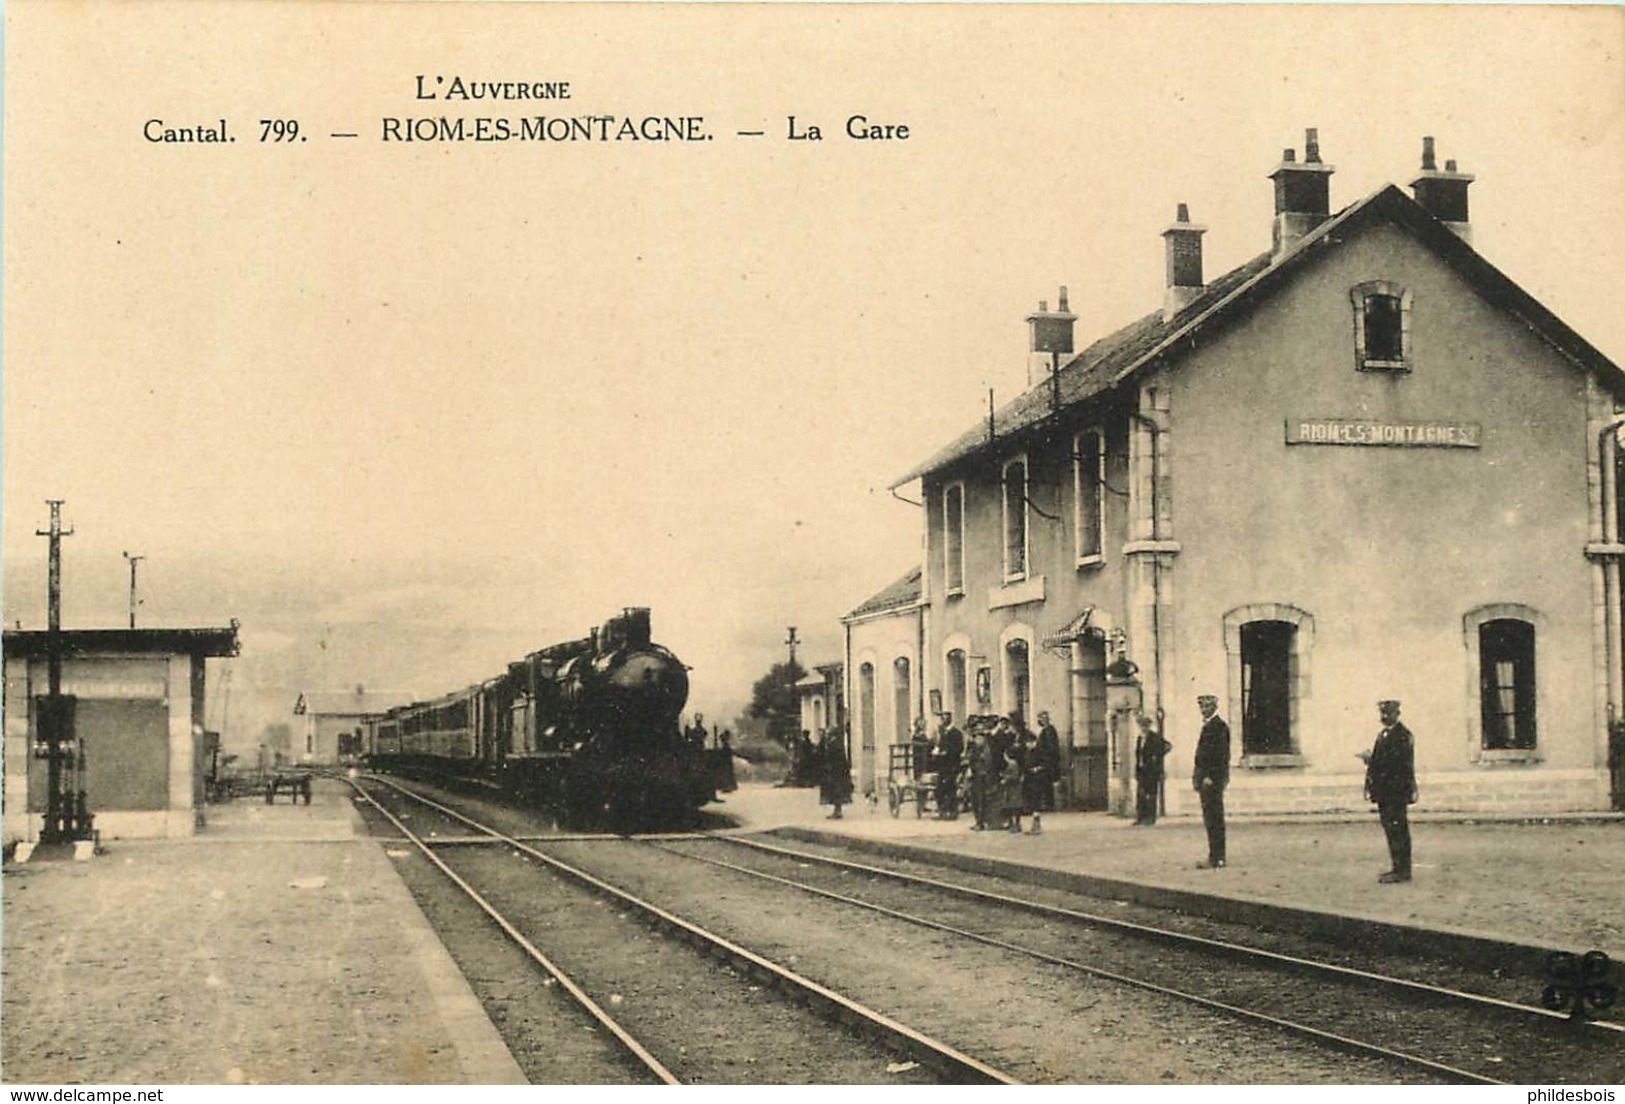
[362,608,735,826]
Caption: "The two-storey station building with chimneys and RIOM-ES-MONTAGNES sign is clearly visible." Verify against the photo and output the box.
[890,132,1625,813]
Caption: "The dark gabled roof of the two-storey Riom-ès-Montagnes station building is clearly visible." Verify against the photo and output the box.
[892,184,1625,488]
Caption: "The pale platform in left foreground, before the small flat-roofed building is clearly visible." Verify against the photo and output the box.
[0,779,525,1084]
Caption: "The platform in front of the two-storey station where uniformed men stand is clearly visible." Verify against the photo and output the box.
[710,784,1625,963]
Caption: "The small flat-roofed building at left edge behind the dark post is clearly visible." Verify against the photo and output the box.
[0,623,239,845]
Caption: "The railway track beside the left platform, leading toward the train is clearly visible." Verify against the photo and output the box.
[346,779,1016,1084]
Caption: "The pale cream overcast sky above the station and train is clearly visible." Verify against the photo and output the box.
[3,3,1625,745]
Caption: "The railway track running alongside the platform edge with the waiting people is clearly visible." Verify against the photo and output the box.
[646,836,1625,1084]
